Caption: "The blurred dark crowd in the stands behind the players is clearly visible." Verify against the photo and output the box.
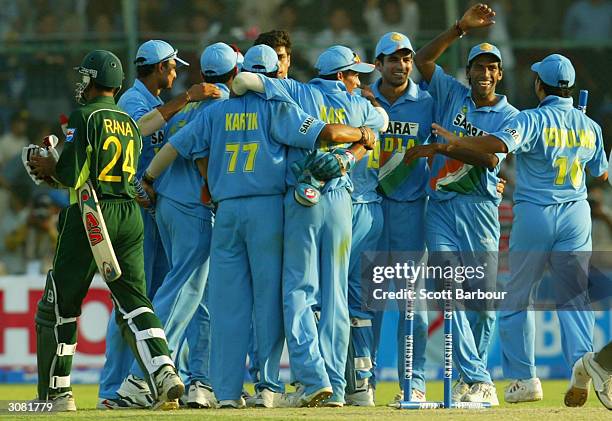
[0,0,612,274]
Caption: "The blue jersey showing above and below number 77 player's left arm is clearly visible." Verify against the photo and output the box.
[157,83,230,219]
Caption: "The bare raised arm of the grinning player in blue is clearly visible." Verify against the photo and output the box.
[414,3,495,82]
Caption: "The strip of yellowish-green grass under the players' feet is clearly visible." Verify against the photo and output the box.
[0,381,612,421]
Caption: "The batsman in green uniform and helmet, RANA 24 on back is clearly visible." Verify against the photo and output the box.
[29,50,184,411]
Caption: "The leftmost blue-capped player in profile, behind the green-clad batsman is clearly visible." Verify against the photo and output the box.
[97,40,220,409]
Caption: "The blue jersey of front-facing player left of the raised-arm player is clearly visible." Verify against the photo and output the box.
[371,79,434,202]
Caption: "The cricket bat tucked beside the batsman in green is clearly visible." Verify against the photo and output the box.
[77,180,121,282]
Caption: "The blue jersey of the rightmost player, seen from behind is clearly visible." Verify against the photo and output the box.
[492,95,608,205]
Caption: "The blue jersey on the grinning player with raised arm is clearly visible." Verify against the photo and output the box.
[427,65,518,204]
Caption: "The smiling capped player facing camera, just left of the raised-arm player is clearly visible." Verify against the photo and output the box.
[364,32,434,401]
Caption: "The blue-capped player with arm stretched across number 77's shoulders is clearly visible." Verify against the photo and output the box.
[233,46,386,406]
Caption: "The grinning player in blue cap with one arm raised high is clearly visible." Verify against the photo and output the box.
[407,4,518,405]
